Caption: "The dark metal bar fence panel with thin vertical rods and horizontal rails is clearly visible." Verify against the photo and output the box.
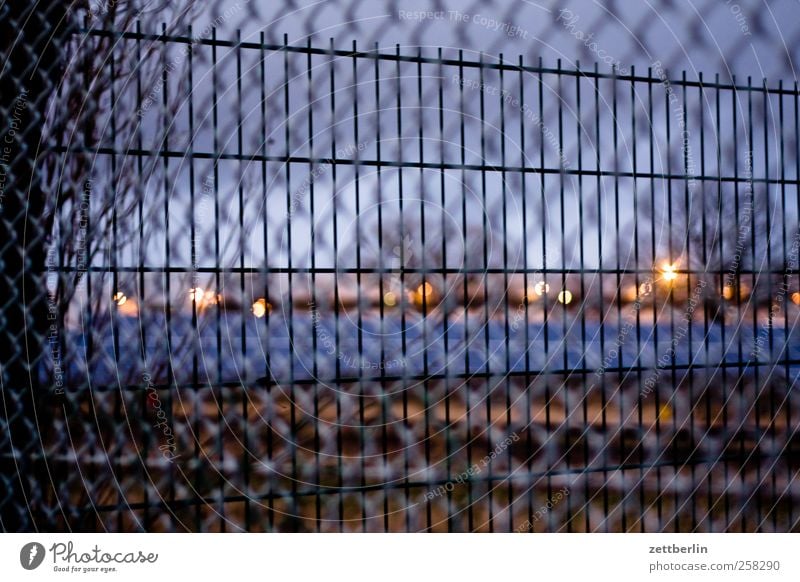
[3,12,800,532]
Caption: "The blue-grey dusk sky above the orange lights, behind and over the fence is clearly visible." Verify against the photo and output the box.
[84,0,800,306]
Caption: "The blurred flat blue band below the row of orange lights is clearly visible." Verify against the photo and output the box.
[45,311,800,386]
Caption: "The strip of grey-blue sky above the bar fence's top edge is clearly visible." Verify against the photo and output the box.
[195,0,800,81]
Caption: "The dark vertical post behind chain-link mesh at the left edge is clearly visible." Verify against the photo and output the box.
[0,2,68,532]
